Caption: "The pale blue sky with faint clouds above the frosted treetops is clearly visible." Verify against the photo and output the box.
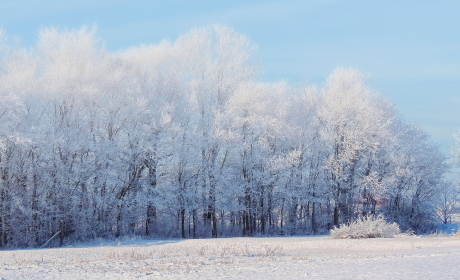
[0,0,460,158]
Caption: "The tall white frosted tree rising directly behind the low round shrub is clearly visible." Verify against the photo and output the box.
[318,68,391,226]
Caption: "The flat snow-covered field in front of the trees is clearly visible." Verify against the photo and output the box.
[0,236,460,280]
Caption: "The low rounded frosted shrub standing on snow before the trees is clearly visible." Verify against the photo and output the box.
[331,215,401,239]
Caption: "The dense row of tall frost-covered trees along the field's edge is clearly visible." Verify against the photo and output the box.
[0,26,446,247]
